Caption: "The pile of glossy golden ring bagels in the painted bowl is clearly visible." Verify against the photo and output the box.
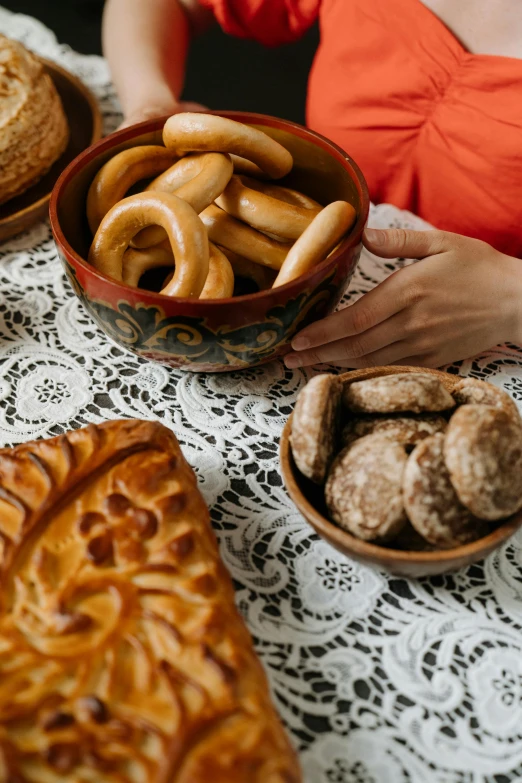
[87,113,356,299]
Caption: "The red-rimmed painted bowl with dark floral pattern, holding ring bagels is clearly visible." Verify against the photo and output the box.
[46,112,369,372]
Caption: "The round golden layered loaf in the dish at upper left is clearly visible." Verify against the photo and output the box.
[0,35,69,204]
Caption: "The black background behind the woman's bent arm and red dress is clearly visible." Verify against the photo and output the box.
[5,0,318,123]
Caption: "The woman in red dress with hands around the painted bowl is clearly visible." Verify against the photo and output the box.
[104,0,522,368]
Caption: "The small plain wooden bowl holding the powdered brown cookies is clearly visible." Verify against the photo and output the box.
[280,367,522,577]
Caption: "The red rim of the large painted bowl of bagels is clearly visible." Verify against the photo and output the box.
[49,111,370,309]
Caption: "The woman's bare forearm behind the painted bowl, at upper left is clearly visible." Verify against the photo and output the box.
[103,0,212,125]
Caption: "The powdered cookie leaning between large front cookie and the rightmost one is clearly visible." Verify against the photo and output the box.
[403,433,487,549]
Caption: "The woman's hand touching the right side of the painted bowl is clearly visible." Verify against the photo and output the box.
[285,229,522,369]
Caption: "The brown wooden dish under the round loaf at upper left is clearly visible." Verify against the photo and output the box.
[0,58,102,242]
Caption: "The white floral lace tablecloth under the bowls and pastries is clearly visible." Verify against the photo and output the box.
[0,8,522,783]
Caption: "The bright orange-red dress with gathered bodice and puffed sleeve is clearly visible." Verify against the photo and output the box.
[200,0,522,257]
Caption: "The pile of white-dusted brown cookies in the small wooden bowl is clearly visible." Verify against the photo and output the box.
[290,372,522,551]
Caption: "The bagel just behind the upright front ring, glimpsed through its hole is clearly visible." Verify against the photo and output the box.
[132,152,234,247]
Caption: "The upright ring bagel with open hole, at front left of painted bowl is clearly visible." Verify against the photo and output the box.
[89,192,209,297]
